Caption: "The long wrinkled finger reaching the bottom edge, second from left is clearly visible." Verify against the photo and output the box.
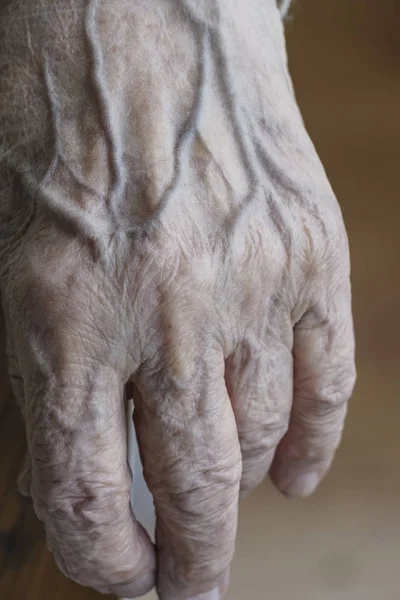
[135,346,241,600]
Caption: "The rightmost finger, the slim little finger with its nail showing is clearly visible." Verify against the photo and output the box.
[271,283,355,496]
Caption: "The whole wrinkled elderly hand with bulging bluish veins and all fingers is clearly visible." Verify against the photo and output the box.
[0,0,355,600]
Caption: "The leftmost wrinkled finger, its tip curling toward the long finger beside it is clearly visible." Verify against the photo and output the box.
[18,325,155,597]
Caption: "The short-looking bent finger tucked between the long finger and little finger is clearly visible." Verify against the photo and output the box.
[225,327,293,496]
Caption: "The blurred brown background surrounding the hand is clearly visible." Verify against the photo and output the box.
[0,0,400,600]
